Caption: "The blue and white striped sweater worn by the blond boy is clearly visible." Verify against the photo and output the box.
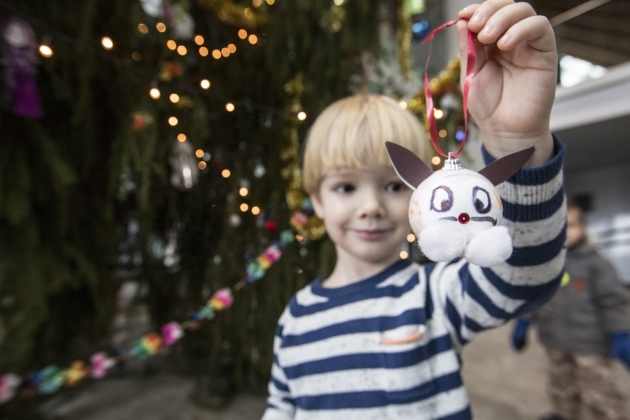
[263,142,565,420]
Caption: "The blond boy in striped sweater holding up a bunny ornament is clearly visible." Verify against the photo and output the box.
[263,0,565,420]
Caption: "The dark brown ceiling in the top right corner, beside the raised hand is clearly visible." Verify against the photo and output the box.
[528,0,630,67]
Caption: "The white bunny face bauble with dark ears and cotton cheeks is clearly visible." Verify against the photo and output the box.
[386,142,534,267]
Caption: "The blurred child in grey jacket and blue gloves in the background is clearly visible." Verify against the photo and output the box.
[512,203,630,420]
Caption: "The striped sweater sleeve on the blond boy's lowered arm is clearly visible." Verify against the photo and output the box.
[262,311,295,420]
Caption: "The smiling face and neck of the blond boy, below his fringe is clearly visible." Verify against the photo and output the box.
[311,166,412,266]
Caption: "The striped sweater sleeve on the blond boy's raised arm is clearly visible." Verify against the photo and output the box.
[429,138,566,346]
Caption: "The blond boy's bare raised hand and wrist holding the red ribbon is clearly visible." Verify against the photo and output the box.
[457,0,558,167]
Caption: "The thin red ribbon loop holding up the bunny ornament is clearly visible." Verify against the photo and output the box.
[422,19,476,158]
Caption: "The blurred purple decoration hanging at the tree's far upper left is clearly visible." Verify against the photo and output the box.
[1,17,43,118]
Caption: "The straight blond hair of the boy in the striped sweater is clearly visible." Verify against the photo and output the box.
[303,94,431,193]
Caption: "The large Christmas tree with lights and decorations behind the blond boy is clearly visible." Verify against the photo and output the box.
[0,0,461,416]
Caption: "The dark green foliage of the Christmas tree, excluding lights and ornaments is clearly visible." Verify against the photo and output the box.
[0,0,386,404]
